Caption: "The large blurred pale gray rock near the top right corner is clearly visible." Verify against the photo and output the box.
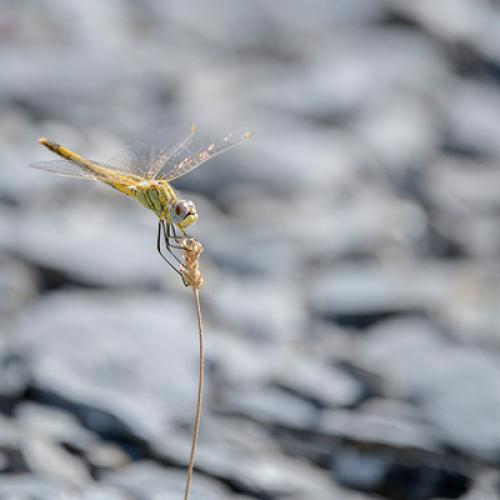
[256,28,448,119]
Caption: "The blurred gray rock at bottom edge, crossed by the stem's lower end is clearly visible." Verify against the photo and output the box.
[153,415,335,500]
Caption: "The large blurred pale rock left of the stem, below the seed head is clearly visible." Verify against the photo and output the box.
[11,292,198,438]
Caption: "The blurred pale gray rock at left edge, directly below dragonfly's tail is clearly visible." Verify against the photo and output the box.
[0,196,176,287]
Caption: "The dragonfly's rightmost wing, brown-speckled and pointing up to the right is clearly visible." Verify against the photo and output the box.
[156,131,252,182]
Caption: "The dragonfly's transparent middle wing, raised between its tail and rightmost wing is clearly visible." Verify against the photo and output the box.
[103,125,196,179]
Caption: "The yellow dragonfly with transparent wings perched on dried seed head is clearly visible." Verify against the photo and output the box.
[30,125,252,284]
